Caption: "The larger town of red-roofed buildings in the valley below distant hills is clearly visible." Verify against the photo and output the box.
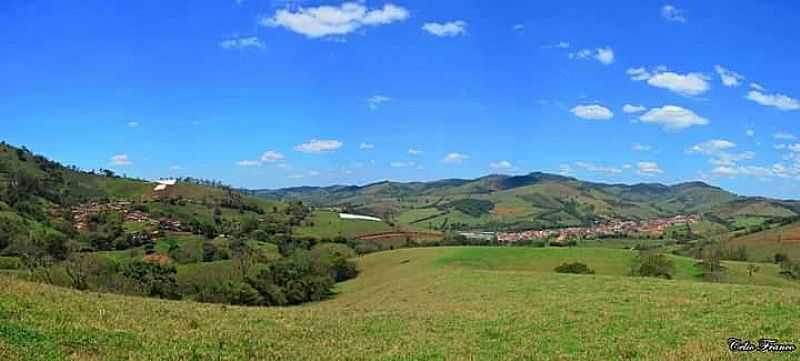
[481,215,700,244]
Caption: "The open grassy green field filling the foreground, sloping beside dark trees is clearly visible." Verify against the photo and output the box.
[0,248,800,360]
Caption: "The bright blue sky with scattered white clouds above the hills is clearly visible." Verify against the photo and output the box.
[0,0,800,198]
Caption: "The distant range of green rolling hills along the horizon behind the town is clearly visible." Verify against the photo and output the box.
[249,172,800,228]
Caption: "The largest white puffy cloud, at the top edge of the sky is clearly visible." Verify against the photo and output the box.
[261,2,409,39]
